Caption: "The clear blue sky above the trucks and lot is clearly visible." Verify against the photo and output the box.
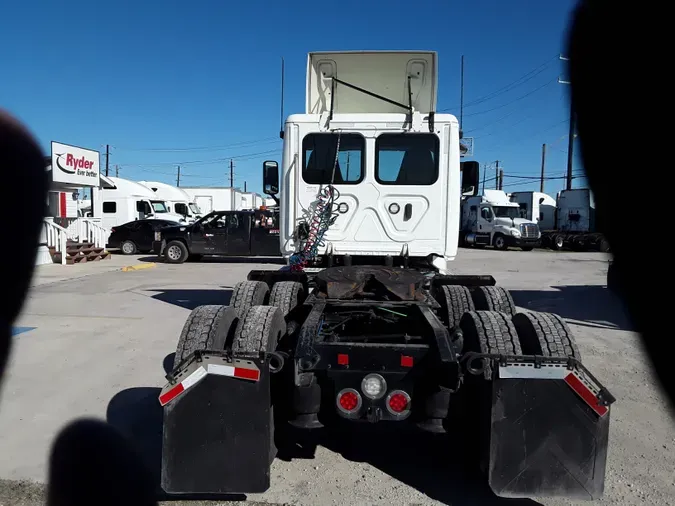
[0,0,585,195]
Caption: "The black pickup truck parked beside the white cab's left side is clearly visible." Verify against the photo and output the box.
[153,209,281,264]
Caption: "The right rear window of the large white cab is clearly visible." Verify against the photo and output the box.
[375,134,440,185]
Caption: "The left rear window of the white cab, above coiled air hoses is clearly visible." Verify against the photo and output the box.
[302,133,365,184]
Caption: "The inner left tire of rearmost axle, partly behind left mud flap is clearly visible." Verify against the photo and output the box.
[232,306,286,464]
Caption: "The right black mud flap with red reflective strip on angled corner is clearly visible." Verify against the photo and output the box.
[488,363,614,499]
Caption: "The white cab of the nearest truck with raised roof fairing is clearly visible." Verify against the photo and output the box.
[264,52,477,272]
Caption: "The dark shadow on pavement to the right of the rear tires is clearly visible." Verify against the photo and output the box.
[509,285,632,330]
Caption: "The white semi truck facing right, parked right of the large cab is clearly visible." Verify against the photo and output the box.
[460,190,541,251]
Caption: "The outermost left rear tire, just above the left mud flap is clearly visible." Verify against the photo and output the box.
[173,305,237,368]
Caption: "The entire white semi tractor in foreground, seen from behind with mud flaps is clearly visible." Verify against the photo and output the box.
[159,51,614,499]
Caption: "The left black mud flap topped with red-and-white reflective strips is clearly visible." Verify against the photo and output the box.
[160,352,271,495]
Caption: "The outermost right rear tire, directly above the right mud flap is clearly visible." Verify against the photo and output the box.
[511,312,581,361]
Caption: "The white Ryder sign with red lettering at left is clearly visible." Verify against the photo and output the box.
[52,141,99,186]
